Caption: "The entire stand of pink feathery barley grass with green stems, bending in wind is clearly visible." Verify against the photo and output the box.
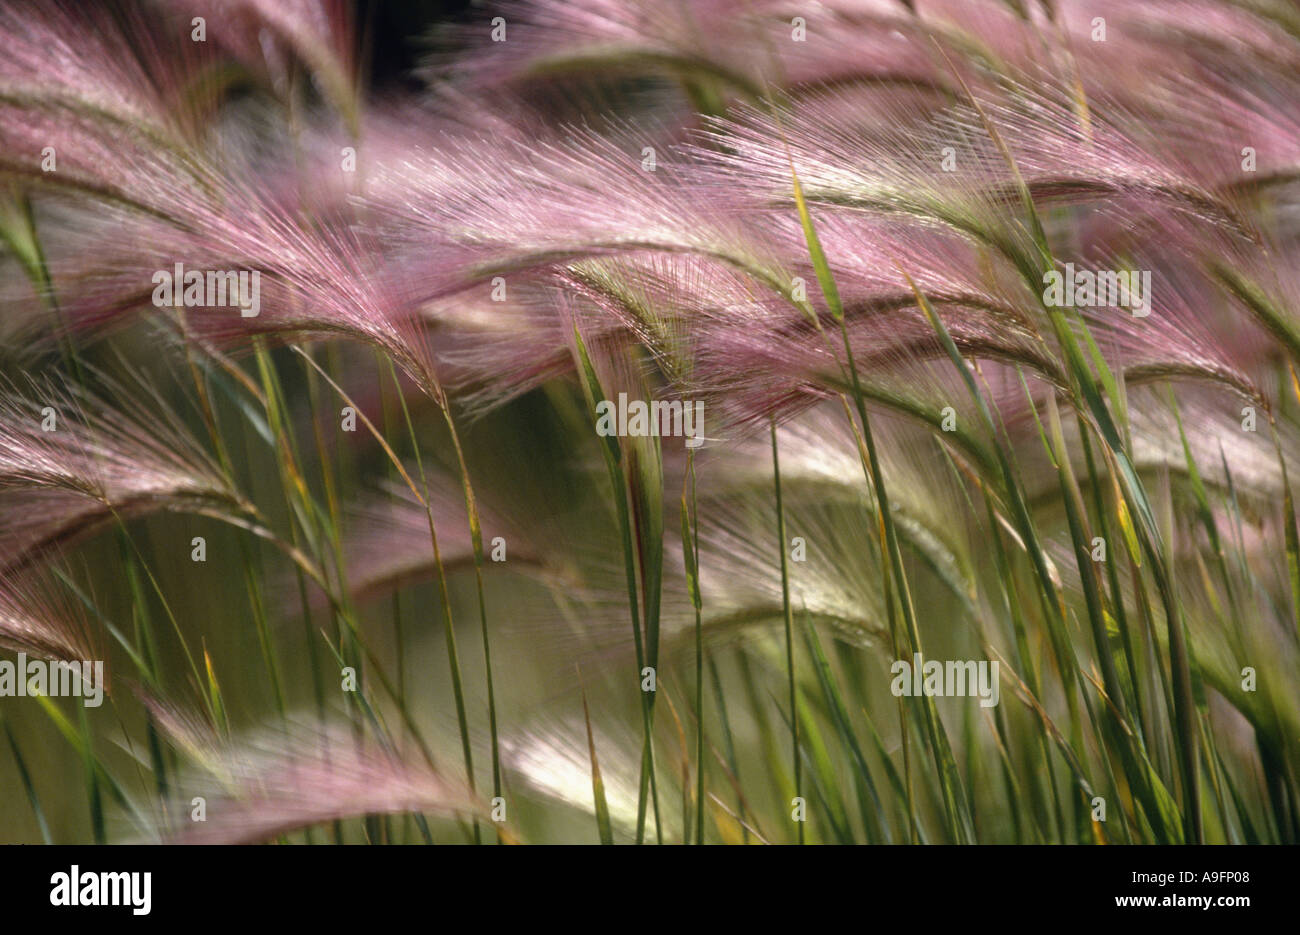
[0,0,1300,843]
